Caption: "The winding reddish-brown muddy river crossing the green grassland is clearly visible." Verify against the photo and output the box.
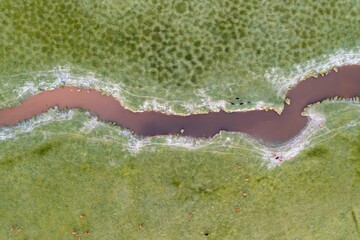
[0,65,360,143]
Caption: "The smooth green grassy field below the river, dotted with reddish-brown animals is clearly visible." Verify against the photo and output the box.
[0,103,360,239]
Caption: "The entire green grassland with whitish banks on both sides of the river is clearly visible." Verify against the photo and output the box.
[0,0,360,240]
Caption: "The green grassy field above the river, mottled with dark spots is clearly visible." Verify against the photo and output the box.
[0,0,360,112]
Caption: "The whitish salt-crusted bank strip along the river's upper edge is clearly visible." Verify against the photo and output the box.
[0,50,360,115]
